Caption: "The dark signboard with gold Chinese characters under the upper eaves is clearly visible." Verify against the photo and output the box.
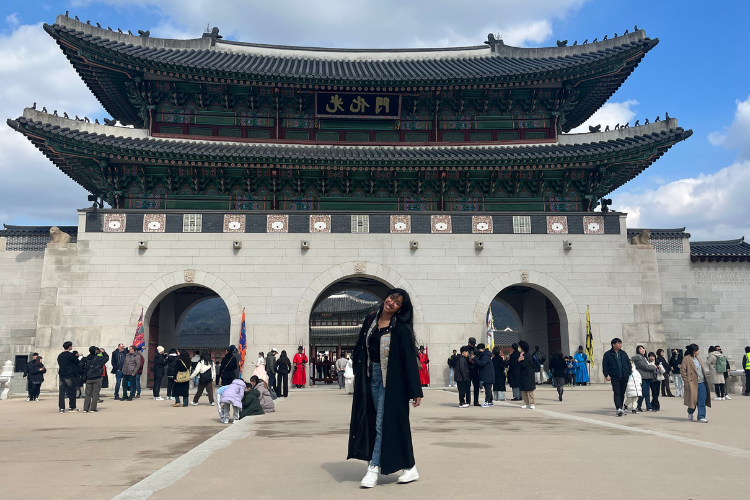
[315,92,401,120]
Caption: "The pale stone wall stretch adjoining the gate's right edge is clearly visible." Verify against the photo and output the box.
[657,250,750,362]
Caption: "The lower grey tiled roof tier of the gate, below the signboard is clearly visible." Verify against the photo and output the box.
[7,113,692,165]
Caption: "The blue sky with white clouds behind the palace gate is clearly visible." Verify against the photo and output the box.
[0,0,750,239]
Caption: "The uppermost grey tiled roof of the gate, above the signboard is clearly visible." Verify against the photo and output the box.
[44,16,658,84]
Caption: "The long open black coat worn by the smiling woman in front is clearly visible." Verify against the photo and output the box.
[346,311,422,474]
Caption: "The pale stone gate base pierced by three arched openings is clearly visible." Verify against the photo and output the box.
[2,209,676,388]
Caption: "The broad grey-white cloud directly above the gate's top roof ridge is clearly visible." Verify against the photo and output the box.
[78,0,589,48]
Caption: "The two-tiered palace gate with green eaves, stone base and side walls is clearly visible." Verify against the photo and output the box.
[0,16,750,387]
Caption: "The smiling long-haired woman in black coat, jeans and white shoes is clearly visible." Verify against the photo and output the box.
[347,288,422,488]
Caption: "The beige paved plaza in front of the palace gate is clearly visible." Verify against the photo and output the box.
[0,385,750,500]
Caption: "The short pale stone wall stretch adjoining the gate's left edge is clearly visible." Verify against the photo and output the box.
[0,246,44,364]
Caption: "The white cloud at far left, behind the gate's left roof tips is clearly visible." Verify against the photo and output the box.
[0,25,106,224]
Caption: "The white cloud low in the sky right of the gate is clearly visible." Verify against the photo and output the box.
[613,98,750,240]
